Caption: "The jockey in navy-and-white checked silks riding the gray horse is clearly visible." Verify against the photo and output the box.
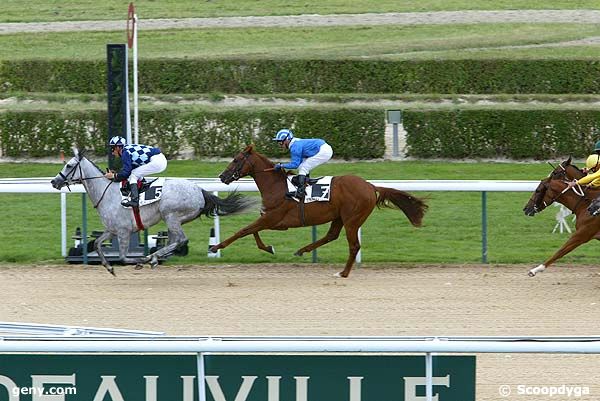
[104,136,167,207]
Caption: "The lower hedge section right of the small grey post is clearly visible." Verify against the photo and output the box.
[404,110,600,160]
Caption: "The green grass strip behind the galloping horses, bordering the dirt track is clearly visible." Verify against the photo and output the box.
[0,157,600,264]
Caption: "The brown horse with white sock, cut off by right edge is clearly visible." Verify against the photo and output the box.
[523,158,600,277]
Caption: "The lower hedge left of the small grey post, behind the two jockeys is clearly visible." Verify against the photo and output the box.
[0,109,385,159]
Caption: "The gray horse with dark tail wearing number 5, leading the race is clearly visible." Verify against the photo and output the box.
[51,150,255,275]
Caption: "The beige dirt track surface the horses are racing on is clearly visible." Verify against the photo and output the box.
[0,264,600,401]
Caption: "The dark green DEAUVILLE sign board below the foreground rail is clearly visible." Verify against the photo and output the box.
[0,354,475,401]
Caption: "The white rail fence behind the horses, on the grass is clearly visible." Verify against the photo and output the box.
[0,177,539,263]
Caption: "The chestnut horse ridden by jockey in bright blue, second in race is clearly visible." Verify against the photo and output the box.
[210,145,427,277]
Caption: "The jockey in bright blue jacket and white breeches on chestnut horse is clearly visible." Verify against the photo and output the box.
[273,129,333,201]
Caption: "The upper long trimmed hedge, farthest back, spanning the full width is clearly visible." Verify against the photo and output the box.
[0,59,600,94]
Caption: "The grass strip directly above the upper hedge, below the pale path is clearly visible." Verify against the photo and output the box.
[0,24,600,60]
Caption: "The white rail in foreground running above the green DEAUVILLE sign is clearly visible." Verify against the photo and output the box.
[0,335,600,401]
